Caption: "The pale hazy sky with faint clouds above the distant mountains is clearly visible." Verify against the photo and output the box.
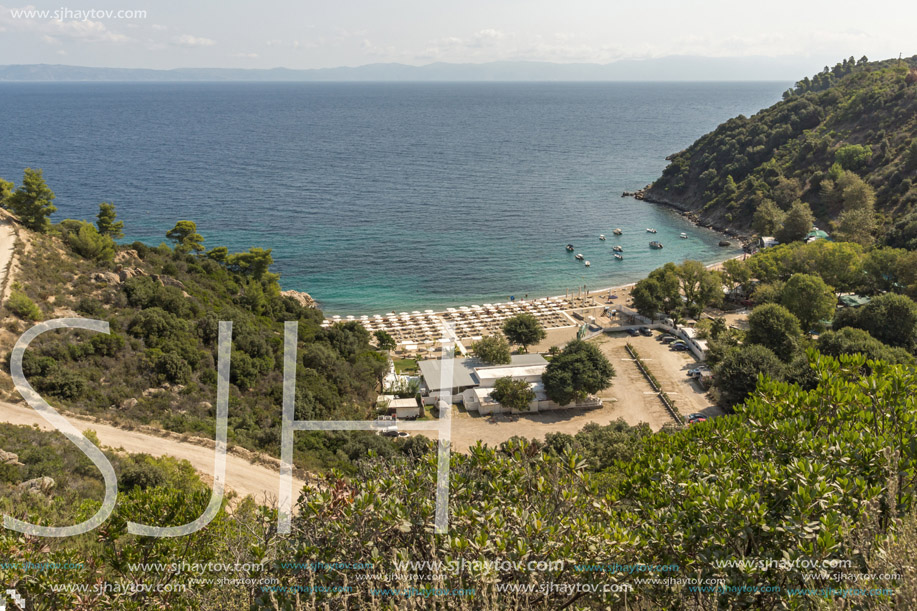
[0,0,917,76]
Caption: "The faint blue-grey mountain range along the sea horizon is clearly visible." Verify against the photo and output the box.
[0,56,833,82]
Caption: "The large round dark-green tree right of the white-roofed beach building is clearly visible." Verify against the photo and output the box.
[542,340,615,405]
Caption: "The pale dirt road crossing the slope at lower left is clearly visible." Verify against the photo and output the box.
[0,401,305,502]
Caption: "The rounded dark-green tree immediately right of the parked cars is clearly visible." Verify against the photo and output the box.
[713,344,784,409]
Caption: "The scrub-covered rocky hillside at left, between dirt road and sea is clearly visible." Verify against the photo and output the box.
[0,170,398,474]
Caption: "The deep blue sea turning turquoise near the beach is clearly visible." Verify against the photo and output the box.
[0,83,787,314]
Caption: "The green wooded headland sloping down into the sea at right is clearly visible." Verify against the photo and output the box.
[644,56,917,248]
